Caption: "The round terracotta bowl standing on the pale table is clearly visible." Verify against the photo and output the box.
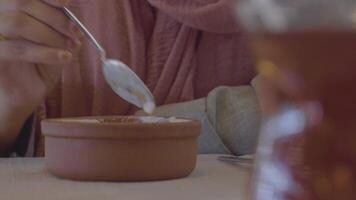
[42,117,200,181]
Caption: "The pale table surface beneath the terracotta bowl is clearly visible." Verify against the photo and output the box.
[0,155,251,200]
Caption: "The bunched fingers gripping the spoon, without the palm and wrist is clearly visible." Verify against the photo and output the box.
[0,0,79,65]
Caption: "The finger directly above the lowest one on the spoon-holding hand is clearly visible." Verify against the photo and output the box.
[0,12,77,49]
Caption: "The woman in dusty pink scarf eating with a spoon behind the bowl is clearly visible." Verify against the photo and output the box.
[0,0,258,155]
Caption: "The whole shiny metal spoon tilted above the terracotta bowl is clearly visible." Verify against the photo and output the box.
[63,7,156,113]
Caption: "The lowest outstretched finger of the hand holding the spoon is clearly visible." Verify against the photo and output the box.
[0,40,73,65]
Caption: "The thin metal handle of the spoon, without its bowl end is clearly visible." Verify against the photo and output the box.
[63,7,106,59]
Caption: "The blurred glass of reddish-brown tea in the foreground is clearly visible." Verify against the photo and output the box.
[237,0,356,200]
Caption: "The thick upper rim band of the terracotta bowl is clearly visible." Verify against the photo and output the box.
[41,116,201,140]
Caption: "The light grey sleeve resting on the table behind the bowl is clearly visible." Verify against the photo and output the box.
[137,77,260,155]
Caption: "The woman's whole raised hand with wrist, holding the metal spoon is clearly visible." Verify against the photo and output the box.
[0,0,80,151]
